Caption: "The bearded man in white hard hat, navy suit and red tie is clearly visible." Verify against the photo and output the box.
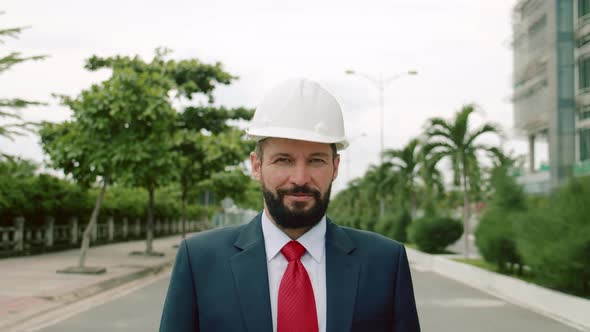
[160,79,420,332]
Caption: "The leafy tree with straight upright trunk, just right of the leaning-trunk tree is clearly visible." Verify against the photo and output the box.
[86,49,235,255]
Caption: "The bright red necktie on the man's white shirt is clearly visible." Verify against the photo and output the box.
[277,241,318,332]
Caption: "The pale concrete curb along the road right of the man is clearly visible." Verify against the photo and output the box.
[406,247,590,332]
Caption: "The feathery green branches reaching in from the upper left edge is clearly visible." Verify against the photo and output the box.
[0,12,46,150]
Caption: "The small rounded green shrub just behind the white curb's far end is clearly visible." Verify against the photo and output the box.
[409,216,463,253]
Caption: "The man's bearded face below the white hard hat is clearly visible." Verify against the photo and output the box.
[250,138,340,228]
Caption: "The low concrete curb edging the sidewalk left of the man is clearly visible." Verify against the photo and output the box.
[0,259,174,331]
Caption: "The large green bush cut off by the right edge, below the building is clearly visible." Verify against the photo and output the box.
[516,178,590,296]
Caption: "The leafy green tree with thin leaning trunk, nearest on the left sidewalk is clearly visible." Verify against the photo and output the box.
[39,78,127,272]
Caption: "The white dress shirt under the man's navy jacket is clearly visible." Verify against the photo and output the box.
[262,210,326,332]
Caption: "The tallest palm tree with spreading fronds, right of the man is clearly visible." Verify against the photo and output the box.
[425,104,499,258]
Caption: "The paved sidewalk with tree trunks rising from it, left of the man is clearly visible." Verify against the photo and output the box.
[0,235,190,331]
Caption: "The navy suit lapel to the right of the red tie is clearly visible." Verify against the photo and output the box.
[326,220,360,332]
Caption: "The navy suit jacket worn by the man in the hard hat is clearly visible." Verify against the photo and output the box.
[160,215,420,332]
